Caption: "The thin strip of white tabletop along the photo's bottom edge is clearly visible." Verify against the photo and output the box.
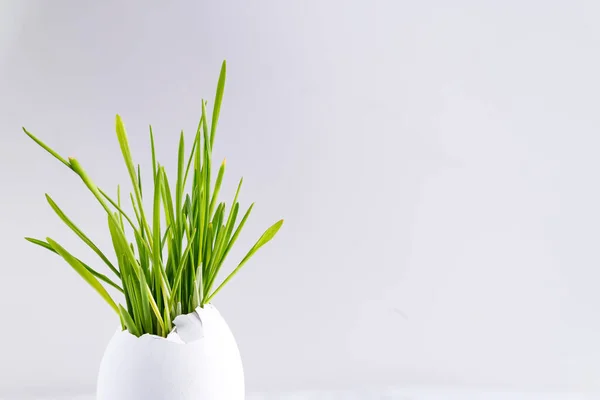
[11,388,600,400]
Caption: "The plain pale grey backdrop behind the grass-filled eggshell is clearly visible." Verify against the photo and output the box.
[0,0,600,395]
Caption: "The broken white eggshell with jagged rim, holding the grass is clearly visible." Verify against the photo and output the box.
[97,305,244,400]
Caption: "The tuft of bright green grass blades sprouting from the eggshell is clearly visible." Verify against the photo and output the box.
[23,61,283,337]
